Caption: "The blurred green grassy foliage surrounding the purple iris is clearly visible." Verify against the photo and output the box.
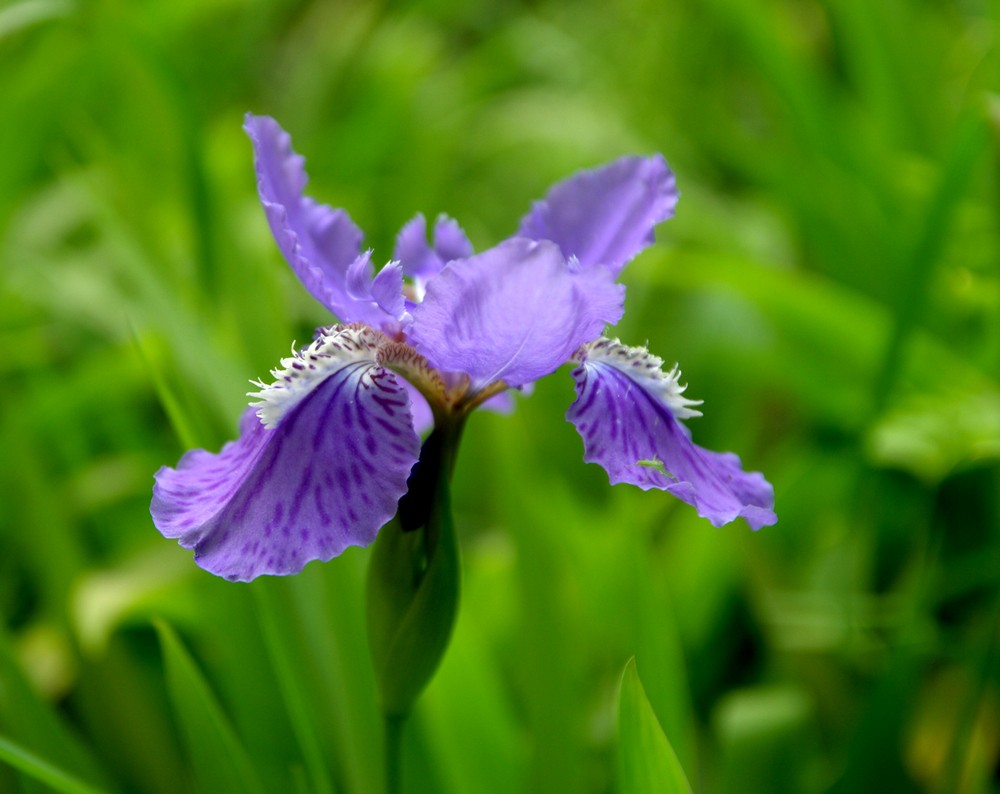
[0,0,1000,794]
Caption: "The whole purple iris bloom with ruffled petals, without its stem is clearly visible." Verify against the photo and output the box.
[151,115,777,581]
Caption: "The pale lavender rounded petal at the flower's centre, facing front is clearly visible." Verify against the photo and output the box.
[409,238,624,388]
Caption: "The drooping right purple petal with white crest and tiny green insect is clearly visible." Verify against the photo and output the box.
[566,339,778,529]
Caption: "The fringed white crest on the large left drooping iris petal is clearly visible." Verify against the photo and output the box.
[247,324,385,428]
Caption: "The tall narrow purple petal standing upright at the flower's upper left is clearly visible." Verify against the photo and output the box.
[243,113,403,326]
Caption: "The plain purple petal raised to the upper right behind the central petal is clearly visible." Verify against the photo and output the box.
[518,155,677,276]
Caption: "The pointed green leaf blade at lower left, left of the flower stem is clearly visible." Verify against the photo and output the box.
[155,621,263,794]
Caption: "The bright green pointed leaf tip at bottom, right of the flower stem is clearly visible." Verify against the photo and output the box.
[617,658,691,794]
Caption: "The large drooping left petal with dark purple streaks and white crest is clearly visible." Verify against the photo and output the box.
[151,326,420,581]
